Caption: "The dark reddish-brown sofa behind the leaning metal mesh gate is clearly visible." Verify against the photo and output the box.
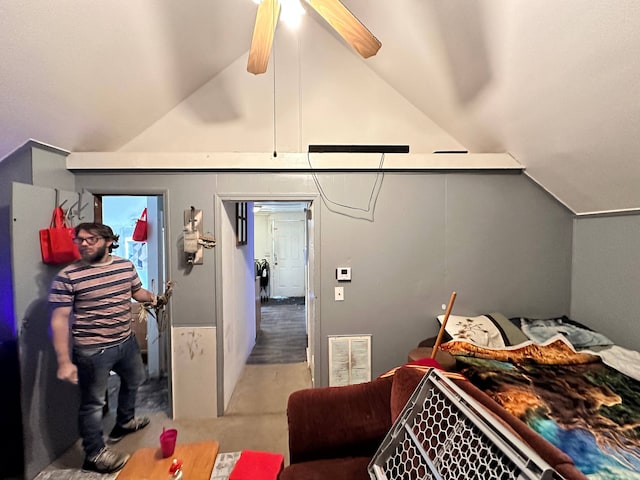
[279,365,587,480]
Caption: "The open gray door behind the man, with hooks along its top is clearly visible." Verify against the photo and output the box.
[11,182,93,478]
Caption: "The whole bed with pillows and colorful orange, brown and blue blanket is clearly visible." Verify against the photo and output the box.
[440,313,640,480]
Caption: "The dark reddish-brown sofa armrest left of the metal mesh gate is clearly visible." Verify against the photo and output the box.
[287,378,392,463]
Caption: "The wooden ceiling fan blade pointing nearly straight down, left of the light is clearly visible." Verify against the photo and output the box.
[247,0,280,75]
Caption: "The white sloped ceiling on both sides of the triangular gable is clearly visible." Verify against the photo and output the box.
[0,0,640,214]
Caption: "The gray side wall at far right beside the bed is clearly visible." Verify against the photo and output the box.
[571,214,640,350]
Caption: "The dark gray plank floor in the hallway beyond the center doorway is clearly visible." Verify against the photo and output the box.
[247,297,307,365]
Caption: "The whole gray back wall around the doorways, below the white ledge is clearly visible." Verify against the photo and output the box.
[76,172,572,385]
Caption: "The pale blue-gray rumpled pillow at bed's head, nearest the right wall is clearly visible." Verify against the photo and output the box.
[510,315,613,348]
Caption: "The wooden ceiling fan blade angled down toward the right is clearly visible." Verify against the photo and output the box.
[307,0,382,58]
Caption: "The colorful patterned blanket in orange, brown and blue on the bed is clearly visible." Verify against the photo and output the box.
[441,341,640,480]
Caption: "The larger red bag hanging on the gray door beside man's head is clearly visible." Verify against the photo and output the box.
[40,207,80,265]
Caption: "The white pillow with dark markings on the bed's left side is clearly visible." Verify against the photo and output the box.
[438,313,529,348]
